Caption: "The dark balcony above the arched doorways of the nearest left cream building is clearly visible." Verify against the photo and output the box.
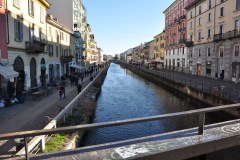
[25,39,46,53]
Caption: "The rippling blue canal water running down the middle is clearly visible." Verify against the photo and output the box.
[81,63,232,146]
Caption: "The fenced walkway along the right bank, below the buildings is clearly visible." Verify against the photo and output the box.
[130,65,240,102]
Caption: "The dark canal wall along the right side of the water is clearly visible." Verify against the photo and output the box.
[114,61,240,117]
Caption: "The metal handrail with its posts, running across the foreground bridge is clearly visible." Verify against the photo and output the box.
[0,104,240,159]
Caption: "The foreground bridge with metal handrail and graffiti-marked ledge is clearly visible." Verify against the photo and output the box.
[0,104,240,160]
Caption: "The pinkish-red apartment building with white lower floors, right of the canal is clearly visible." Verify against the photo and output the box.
[163,0,187,71]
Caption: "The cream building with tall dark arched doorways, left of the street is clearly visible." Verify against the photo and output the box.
[6,0,50,96]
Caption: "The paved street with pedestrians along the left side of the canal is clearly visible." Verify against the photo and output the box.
[0,74,93,159]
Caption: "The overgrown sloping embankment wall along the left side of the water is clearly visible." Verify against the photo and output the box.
[55,68,108,150]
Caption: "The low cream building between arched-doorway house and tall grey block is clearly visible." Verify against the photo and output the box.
[46,15,75,82]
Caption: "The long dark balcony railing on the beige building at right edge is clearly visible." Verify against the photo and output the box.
[214,28,240,42]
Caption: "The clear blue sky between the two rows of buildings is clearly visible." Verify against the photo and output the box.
[83,0,174,56]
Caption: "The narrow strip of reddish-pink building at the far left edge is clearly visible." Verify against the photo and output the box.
[0,0,8,62]
